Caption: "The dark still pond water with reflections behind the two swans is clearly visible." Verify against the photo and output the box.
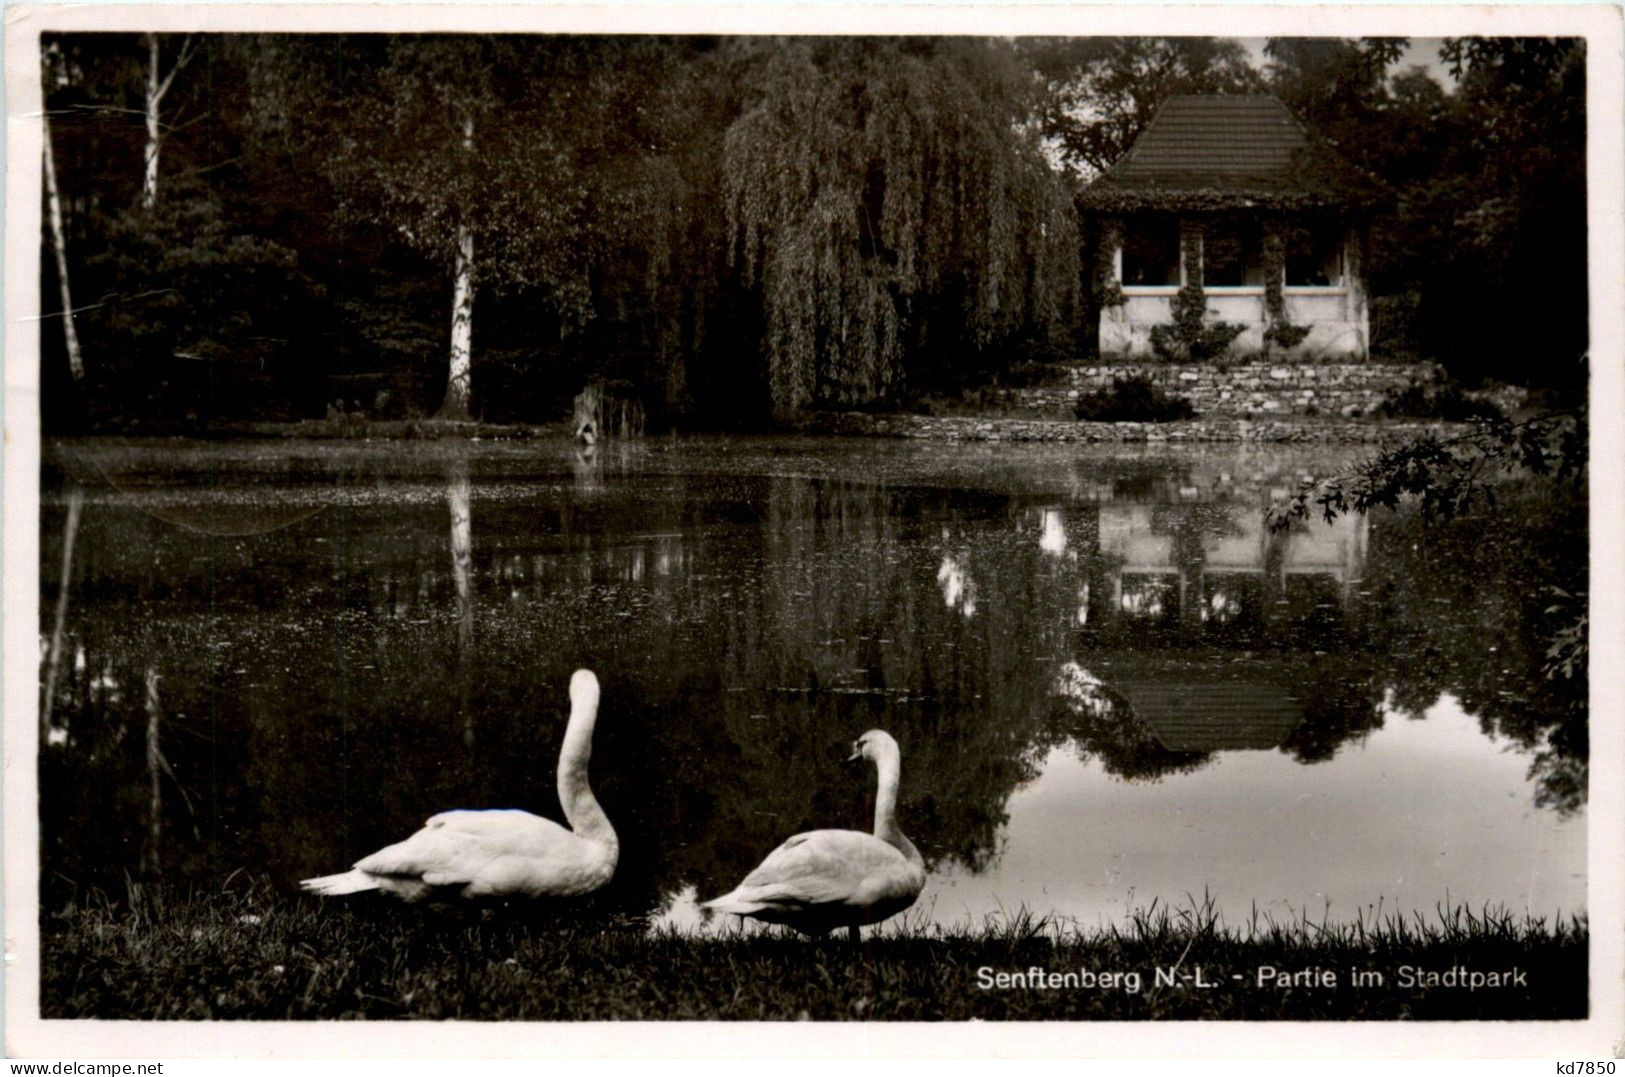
[39,439,1586,926]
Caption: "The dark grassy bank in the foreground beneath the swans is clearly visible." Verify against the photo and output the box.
[41,889,1588,1020]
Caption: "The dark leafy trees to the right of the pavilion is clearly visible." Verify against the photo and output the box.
[1266,37,1588,388]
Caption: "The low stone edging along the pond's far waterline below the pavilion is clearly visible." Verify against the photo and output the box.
[798,411,1464,445]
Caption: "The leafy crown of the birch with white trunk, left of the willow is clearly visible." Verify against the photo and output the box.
[310,34,593,316]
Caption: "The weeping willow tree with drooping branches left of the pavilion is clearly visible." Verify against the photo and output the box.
[723,39,1077,411]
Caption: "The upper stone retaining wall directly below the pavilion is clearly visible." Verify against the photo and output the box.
[998,362,1445,419]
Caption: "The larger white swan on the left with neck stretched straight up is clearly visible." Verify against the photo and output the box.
[299,669,621,902]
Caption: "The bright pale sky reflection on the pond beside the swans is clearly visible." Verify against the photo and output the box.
[920,699,1586,924]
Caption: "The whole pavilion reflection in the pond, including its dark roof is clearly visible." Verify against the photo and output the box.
[1038,489,1370,756]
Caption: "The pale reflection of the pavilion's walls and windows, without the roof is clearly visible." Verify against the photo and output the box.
[1097,502,1368,624]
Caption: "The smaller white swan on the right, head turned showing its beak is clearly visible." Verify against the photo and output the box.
[704,729,925,941]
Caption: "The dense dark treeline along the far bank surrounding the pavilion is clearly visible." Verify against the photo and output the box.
[41,34,1588,429]
